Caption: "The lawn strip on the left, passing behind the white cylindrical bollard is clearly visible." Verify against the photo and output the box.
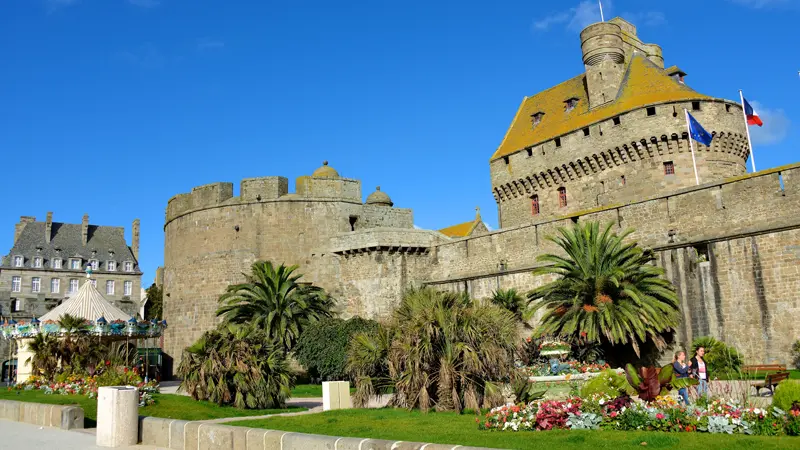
[0,390,306,428]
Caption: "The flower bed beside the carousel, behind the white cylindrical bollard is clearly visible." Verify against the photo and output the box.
[16,372,159,406]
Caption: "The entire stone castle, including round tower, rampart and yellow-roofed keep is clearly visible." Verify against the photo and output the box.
[164,18,800,372]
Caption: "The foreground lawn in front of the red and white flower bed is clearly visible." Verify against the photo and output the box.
[230,409,800,450]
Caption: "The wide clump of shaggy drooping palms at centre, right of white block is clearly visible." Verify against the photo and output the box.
[348,288,517,411]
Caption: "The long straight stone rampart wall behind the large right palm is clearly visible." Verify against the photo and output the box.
[426,164,800,365]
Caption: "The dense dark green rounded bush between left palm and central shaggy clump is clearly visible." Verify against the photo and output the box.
[295,317,379,380]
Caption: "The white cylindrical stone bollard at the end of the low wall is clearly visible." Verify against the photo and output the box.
[97,386,139,447]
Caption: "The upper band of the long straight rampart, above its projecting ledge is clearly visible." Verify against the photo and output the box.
[429,164,800,283]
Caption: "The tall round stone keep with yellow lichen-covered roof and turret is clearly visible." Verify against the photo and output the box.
[490,18,750,228]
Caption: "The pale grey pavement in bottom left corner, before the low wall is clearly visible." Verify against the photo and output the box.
[0,420,158,450]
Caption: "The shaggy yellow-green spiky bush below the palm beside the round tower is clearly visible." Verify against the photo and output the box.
[178,325,294,409]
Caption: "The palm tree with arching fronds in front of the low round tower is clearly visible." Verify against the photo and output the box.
[217,261,334,351]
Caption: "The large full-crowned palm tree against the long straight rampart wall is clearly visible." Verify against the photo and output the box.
[529,222,680,356]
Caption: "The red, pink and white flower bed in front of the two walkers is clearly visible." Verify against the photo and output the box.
[476,395,800,436]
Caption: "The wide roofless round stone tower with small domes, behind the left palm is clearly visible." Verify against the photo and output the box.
[164,161,417,368]
